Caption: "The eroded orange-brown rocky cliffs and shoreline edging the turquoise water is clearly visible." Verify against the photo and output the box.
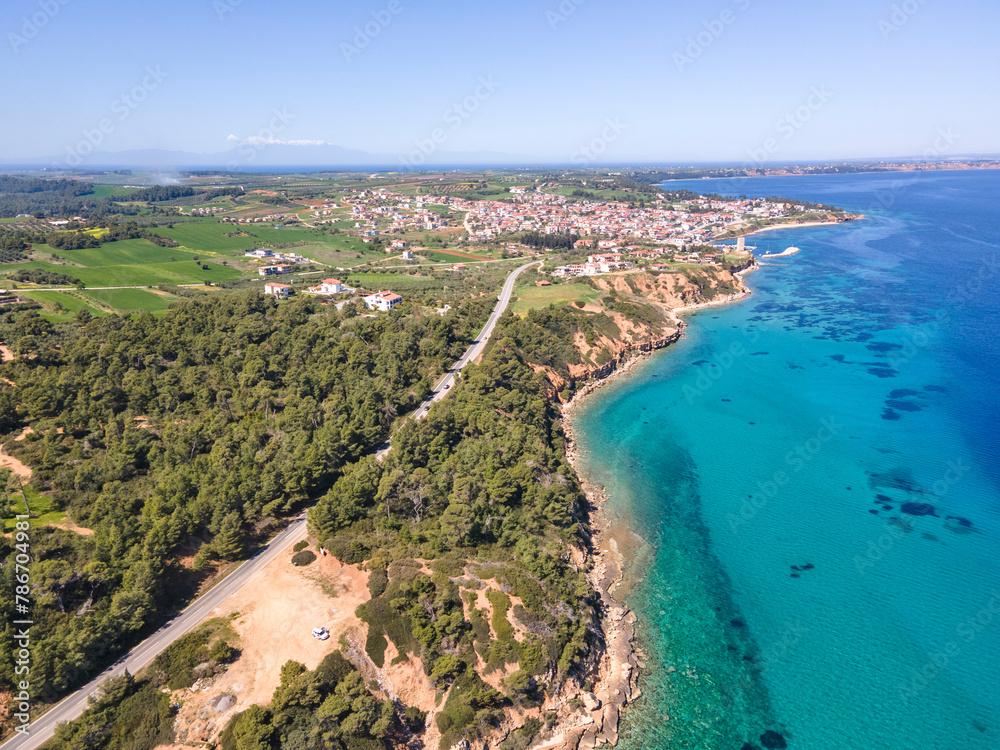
[508,257,756,750]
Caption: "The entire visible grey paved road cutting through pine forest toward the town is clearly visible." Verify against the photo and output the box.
[0,261,541,750]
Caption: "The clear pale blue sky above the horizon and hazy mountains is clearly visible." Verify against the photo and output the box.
[0,0,1000,163]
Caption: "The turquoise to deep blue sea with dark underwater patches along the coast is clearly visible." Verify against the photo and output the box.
[573,171,1000,750]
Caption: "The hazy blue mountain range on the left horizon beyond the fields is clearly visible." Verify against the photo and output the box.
[0,143,545,172]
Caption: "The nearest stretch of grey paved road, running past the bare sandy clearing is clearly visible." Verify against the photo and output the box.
[0,513,306,750]
